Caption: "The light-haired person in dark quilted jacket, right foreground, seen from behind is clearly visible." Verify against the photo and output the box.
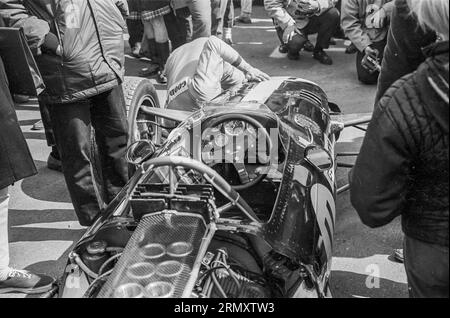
[350,0,449,298]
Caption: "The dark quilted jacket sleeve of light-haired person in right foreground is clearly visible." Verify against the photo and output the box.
[350,90,410,227]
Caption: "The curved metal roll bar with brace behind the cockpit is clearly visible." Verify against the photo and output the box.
[143,156,262,223]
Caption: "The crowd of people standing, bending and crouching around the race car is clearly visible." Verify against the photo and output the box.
[0,0,449,297]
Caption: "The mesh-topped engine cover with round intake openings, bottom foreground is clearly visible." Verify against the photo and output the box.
[98,211,213,298]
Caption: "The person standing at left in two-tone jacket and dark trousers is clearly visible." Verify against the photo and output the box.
[0,0,128,226]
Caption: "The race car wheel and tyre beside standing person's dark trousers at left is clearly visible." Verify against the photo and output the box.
[122,76,161,145]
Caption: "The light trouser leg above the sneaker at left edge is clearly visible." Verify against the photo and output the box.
[0,188,9,281]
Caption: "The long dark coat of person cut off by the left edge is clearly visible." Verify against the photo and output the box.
[0,54,37,189]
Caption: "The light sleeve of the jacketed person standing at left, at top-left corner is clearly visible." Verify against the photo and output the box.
[0,0,50,54]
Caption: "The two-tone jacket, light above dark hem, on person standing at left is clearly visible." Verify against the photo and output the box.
[0,0,129,103]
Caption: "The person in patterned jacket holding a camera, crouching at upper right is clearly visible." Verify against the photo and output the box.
[341,0,394,85]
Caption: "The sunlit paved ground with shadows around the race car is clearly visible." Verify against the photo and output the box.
[2,7,407,297]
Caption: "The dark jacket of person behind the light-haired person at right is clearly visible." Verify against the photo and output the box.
[375,0,436,104]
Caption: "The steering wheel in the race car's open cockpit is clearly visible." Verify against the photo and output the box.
[197,114,273,191]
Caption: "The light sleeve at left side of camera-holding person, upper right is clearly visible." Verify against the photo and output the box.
[341,0,372,52]
